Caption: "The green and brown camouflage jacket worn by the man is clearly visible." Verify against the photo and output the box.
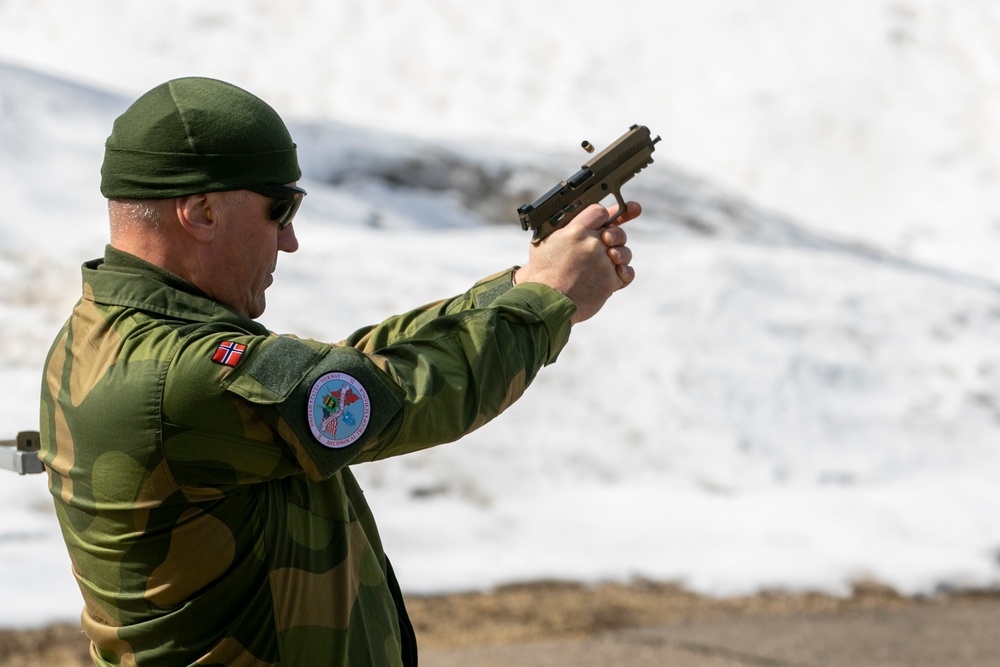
[41,247,573,667]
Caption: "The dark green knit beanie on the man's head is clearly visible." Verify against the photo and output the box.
[101,77,302,199]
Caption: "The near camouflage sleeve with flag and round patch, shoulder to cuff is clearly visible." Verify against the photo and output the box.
[164,274,574,487]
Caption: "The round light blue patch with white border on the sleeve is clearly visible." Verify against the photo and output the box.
[307,373,372,448]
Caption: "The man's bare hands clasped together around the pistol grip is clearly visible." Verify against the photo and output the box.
[514,202,642,324]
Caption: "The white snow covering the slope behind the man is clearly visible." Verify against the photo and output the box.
[0,0,1000,626]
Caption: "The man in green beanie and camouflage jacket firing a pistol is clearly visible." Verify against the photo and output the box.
[41,78,639,667]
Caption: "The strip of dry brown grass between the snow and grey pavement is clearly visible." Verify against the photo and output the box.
[0,581,988,667]
